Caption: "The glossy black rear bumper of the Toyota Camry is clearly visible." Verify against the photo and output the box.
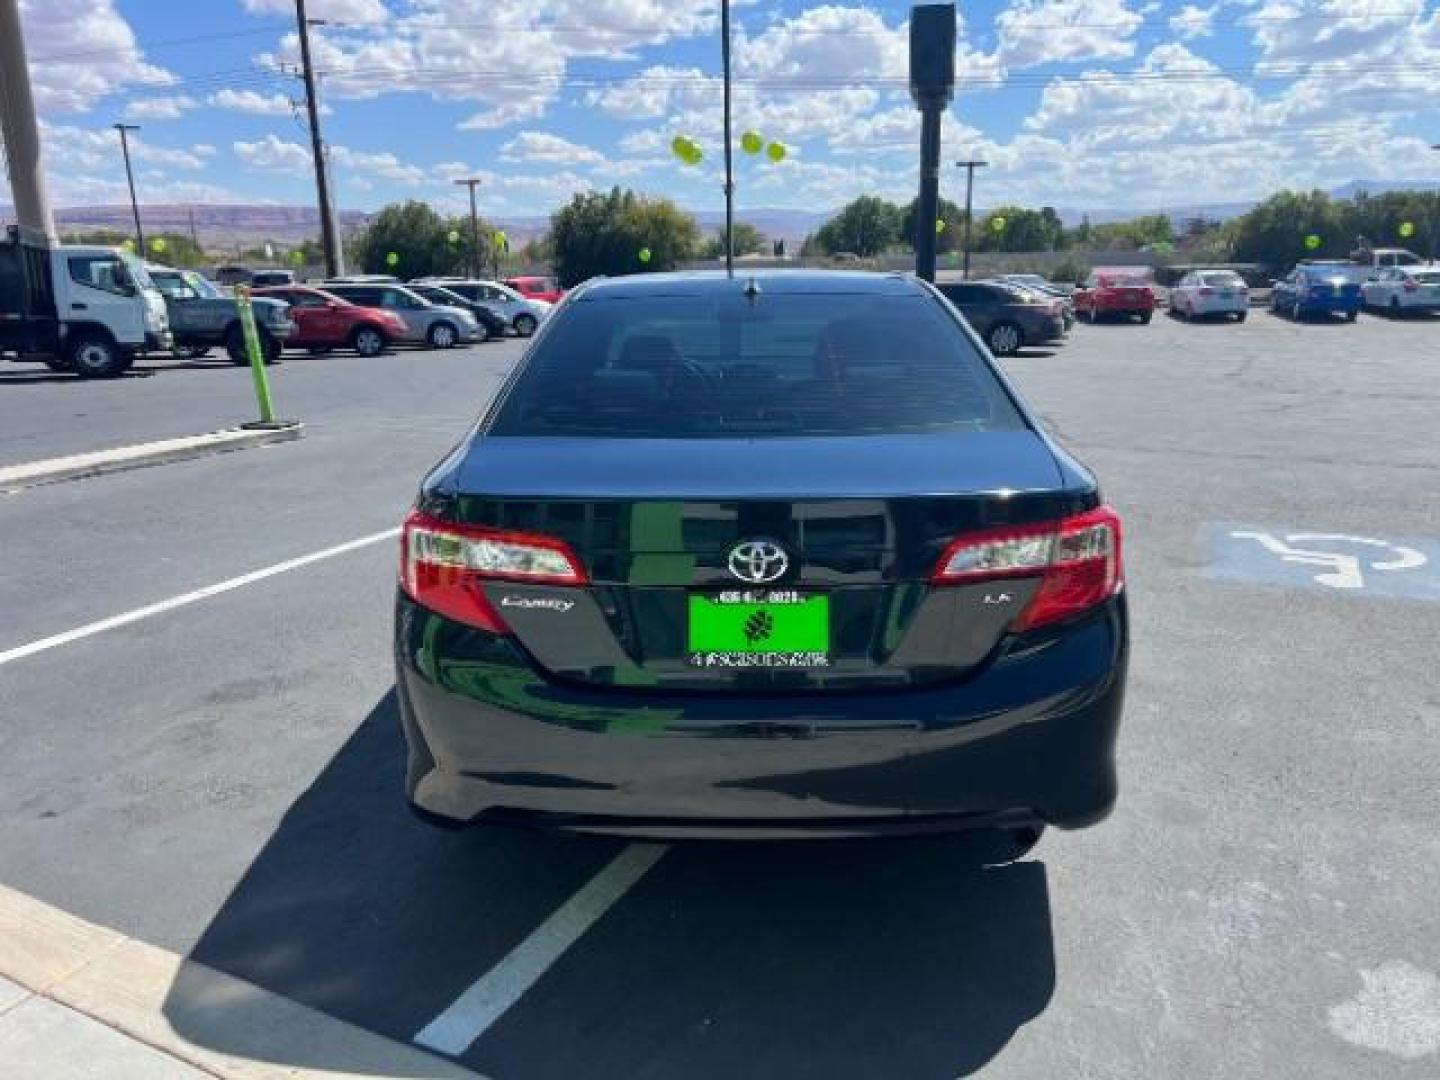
[396,596,1128,838]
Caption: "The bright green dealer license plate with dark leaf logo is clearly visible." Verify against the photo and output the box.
[687,589,829,668]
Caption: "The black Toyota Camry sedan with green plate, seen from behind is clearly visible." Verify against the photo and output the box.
[395,271,1128,845]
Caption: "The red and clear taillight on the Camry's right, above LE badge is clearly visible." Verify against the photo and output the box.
[930,507,1125,631]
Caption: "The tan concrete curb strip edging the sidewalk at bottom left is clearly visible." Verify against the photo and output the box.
[0,886,484,1080]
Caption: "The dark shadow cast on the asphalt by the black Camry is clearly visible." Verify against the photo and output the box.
[164,691,1056,1079]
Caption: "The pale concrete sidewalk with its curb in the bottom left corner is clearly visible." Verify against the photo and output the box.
[0,884,482,1080]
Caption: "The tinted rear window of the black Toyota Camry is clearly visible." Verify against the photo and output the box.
[488,294,1025,438]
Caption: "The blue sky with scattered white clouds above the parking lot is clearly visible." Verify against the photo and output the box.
[22,0,1440,215]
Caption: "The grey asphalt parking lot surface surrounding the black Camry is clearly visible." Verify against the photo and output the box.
[0,311,1440,1080]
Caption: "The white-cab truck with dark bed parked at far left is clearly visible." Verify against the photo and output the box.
[0,233,173,379]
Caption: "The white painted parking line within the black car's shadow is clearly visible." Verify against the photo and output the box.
[415,844,668,1054]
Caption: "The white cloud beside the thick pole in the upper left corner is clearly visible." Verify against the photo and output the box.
[20,0,176,114]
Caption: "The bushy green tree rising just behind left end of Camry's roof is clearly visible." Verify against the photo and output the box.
[550,187,700,288]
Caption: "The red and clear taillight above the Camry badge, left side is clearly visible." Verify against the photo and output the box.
[400,510,586,634]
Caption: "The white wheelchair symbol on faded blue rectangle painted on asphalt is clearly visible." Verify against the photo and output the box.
[1207,524,1440,602]
